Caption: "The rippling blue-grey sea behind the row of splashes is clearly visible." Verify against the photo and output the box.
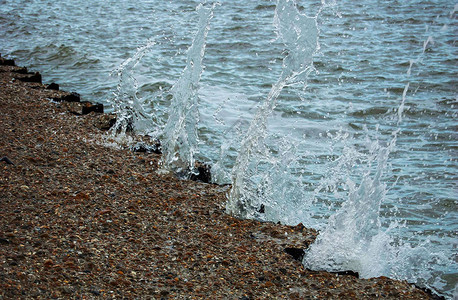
[0,0,458,297]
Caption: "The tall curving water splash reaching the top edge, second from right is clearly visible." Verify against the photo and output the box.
[226,0,319,219]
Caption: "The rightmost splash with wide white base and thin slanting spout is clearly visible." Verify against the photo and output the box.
[303,17,453,296]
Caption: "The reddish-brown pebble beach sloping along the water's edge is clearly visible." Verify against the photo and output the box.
[0,56,436,299]
